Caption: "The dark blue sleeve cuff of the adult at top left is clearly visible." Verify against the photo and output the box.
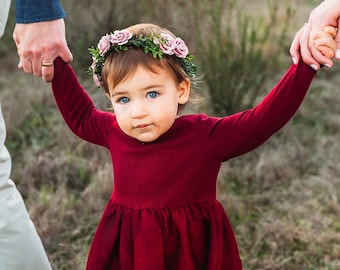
[15,0,66,23]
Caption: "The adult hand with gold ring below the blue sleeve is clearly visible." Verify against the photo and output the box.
[13,19,73,82]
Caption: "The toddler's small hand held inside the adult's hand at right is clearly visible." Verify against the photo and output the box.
[311,26,337,59]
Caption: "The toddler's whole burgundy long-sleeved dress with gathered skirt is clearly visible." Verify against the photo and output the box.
[52,59,315,270]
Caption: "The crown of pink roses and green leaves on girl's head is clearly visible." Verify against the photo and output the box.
[88,30,197,87]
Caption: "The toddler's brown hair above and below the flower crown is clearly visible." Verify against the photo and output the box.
[102,24,202,110]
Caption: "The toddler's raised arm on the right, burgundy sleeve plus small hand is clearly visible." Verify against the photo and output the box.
[216,27,336,160]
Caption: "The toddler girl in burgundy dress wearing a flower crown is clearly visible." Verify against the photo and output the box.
[52,24,335,270]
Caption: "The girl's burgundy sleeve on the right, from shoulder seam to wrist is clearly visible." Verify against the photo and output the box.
[204,61,315,160]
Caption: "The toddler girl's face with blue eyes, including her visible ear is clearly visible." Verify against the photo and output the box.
[107,66,190,142]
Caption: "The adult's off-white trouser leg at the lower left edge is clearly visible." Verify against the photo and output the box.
[0,102,52,270]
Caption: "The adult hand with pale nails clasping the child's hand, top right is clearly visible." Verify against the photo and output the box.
[290,0,340,70]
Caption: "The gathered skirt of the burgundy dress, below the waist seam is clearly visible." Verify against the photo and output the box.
[87,199,242,270]
